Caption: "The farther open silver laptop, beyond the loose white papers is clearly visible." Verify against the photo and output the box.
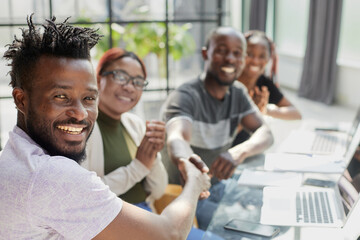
[278,108,360,156]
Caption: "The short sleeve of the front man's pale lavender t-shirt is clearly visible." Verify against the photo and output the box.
[28,157,122,239]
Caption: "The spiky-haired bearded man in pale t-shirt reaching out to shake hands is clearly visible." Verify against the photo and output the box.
[0,17,209,239]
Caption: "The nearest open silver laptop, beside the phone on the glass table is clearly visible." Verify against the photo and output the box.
[260,156,359,227]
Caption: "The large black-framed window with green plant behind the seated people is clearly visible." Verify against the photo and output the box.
[0,0,229,149]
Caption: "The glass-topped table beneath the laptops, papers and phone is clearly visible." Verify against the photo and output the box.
[202,116,360,240]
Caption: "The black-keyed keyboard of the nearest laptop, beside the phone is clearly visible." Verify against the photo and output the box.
[296,192,334,223]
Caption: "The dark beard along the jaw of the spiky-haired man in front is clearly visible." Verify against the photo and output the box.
[26,110,90,163]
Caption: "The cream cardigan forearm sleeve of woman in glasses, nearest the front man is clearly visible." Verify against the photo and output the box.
[101,159,150,196]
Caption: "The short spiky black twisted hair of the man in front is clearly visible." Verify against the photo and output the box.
[4,14,101,90]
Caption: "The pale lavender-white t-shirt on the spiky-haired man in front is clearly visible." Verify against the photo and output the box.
[0,127,122,239]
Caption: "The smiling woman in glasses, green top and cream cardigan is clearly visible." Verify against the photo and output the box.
[82,48,168,210]
